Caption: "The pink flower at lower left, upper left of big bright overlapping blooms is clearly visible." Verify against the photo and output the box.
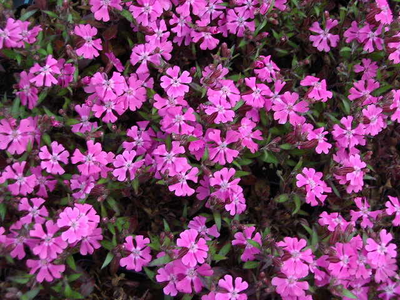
[18,198,49,224]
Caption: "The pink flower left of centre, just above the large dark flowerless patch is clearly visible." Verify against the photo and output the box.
[113,150,144,181]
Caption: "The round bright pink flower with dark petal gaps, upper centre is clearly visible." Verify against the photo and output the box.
[160,66,192,97]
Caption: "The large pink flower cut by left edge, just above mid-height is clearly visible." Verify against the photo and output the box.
[0,119,34,154]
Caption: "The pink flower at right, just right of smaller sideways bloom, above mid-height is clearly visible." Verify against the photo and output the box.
[332,116,365,148]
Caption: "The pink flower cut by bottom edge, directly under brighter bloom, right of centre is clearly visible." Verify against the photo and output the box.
[271,271,309,299]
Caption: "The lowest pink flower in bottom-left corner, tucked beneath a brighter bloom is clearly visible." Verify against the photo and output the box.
[26,259,65,282]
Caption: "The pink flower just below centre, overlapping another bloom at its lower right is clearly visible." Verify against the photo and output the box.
[209,168,240,201]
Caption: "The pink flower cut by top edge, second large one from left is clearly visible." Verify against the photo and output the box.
[129,0,163,26]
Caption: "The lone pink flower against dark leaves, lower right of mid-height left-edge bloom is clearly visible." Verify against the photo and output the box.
[39,141,69,175]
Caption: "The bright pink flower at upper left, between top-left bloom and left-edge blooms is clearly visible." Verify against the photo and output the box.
[29,55,61,87]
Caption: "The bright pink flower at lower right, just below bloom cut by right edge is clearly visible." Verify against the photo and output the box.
[365,229,397,266]
